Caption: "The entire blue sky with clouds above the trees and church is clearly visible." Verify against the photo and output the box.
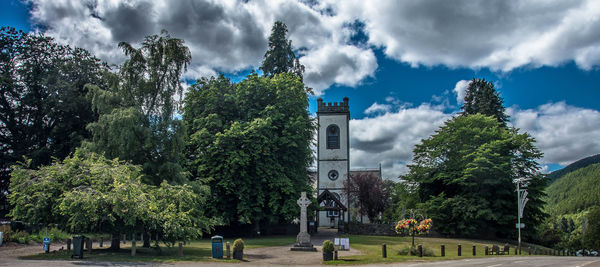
[0,0,600,178]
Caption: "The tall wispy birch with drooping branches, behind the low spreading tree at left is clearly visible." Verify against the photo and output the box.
[86,32,191,185]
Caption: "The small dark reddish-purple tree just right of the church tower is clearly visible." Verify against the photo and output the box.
[343,173,390,222]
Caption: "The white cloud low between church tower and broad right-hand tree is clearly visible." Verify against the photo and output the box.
[350,104,452,178]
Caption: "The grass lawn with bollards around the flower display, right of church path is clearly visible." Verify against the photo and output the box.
[326,235,548,264]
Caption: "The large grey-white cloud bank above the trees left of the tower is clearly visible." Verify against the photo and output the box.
[29,0,377,94]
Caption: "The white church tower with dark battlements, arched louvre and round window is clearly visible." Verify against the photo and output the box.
[317,97,350,227]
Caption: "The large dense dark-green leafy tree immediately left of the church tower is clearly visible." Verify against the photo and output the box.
[183,73,315,230]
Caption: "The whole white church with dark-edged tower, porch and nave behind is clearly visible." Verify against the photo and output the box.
[310,97,382,228]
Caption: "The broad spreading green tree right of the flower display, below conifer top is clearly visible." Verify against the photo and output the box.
[405,114,546,237]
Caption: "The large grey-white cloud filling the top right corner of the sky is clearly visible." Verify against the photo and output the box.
[323,0,600,71]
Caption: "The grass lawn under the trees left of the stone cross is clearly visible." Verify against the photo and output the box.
[21,236,296,262]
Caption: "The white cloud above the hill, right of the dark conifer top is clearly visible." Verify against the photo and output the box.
[507,102,600,166]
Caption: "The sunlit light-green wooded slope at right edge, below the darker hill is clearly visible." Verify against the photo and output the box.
[546,164,600,216]
